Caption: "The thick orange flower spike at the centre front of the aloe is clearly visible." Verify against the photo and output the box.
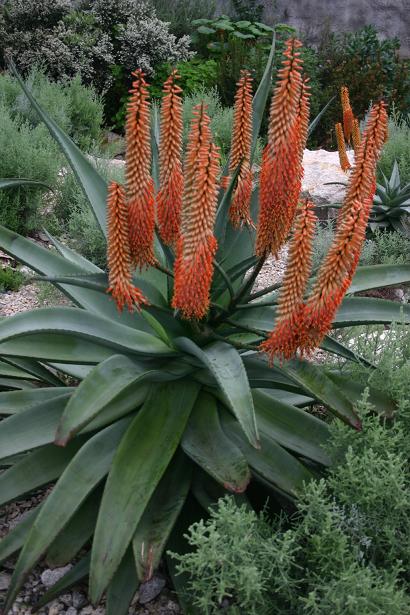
[172,105,219,320]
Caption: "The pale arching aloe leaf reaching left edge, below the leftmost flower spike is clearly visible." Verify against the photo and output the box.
[0,307,175,363]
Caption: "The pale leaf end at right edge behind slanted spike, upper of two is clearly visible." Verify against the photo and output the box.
[347,263,410,294]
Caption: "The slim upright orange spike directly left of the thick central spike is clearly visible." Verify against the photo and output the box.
[157,70,184,245]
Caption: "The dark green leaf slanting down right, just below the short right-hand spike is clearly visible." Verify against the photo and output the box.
[282,359,361,429]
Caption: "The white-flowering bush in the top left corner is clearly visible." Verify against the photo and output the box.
[0,0,192,92]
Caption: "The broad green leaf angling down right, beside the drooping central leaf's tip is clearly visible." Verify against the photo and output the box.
[252,390,329,465]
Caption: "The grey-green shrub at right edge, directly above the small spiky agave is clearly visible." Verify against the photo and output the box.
[378,110,410,184]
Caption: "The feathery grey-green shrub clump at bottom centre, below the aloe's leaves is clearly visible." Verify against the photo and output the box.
[172,497,296,615]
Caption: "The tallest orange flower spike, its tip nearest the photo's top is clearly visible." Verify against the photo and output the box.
[256,39,308,256]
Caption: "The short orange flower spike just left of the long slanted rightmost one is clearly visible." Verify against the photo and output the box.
[260,200,317,361]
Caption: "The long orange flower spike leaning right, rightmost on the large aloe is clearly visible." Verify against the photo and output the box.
[301,102,388,352]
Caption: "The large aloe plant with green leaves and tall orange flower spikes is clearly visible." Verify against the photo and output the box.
[0,40,410,615]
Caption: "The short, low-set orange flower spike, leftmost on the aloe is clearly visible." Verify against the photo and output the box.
[107,182,148,312]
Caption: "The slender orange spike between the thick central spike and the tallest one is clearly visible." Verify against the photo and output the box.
[229,71,253,227]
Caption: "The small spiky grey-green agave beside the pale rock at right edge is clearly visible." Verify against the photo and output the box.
[369,160,410,236]
